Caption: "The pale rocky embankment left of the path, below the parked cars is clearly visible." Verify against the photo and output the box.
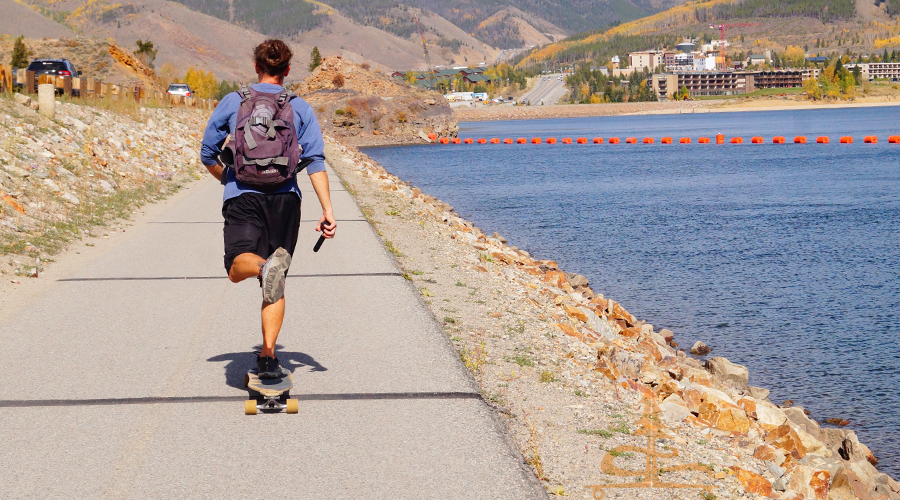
[0,95,209,280]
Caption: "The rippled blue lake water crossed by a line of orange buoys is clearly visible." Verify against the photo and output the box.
[365,107,900,478]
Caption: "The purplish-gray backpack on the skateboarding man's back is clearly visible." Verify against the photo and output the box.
[223,87,302,193]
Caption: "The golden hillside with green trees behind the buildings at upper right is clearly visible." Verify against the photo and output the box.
[518,0,900,67]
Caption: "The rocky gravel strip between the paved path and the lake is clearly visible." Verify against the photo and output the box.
[326,135,900,500]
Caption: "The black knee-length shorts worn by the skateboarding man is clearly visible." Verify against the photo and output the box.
[222,193,300,272]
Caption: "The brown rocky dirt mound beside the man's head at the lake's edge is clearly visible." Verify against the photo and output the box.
[294,56,458,146]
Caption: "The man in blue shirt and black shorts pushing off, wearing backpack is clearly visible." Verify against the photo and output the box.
[200,39,337,378]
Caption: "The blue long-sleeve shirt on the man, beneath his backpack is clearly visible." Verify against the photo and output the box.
[200,83,325,202]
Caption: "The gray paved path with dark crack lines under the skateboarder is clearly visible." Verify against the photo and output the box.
[0,172,546,499]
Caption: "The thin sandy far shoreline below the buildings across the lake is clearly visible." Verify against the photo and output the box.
[453,99,900,122]
